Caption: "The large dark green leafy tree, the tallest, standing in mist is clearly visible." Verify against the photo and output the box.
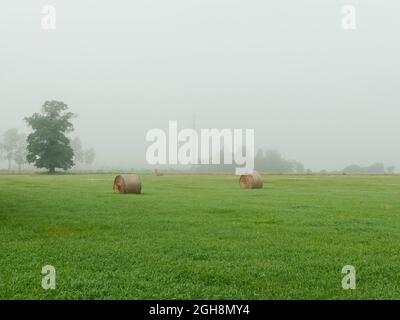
[25,100,74,173]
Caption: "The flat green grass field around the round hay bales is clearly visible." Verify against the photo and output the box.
[0,174,400,299]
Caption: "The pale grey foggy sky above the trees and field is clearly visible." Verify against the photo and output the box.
[0,0,400,170]
